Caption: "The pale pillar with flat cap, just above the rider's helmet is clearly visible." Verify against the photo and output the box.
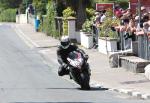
[68,17,76,40]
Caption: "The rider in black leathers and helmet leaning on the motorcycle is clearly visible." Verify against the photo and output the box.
[57,36,89,76]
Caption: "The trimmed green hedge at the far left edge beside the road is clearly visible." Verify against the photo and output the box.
[0,9,16,22]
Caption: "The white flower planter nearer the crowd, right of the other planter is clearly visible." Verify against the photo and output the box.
[98,37,117,54]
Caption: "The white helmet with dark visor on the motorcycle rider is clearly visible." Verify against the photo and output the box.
[60,36,70,49]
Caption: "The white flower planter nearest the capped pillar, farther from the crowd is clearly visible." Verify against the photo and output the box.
[80,32,93,49]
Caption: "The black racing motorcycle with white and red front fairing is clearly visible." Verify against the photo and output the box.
[67,51,90,90]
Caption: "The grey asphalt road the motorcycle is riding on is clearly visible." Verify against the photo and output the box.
[0,24,148,103]
